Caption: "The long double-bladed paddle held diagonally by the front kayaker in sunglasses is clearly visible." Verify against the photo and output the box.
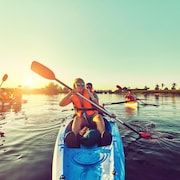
[31,61,152,139]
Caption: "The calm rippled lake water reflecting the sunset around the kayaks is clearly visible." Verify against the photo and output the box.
[0,94,180,180]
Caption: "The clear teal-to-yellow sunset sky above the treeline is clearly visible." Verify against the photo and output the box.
[0,0,180,90]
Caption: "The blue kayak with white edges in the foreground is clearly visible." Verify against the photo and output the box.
[52,117,125,180]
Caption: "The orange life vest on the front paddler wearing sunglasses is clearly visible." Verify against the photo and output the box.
[72,89,97,116]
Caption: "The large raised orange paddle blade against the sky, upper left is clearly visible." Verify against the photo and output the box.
[31,61,56,80]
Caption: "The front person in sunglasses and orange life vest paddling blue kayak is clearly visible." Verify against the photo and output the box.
[59,78,112,148]
